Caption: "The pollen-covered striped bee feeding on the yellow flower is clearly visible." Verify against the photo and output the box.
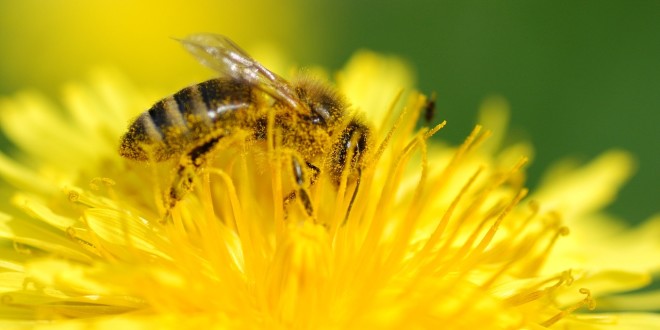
[119,34,370,216]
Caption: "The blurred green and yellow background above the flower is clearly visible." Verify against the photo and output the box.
[0,0,660,223]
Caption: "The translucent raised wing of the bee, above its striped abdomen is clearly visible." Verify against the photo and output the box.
[177,34,301,109]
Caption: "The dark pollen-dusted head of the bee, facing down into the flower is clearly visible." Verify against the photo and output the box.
[329,119,370,185]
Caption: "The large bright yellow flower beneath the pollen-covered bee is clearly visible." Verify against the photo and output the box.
[0,47,660,329]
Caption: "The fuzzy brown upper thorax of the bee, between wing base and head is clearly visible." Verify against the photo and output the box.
[294,76,346,125]
